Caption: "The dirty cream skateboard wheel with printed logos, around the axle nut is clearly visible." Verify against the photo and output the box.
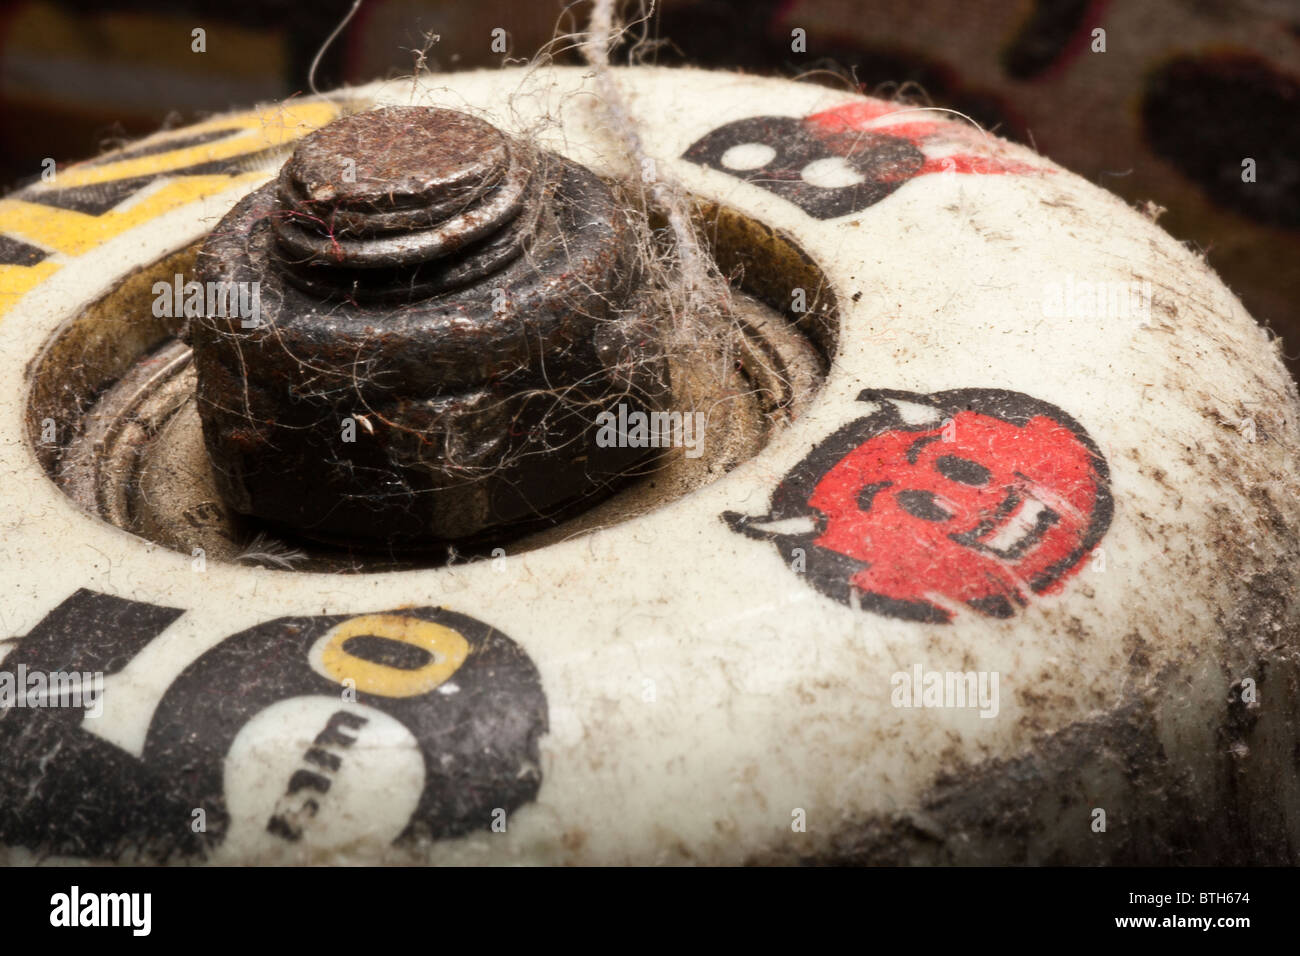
[0,63,1300,864]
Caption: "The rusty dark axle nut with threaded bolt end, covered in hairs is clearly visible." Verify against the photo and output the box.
[187,107,668,546]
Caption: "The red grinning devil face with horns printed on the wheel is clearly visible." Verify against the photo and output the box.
[723,389,1113,623]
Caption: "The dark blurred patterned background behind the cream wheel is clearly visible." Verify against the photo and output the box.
[0,0,1300,382]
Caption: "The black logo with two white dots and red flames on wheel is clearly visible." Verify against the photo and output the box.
[683,100,1050,219]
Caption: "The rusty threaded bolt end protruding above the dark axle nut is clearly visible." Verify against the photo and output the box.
[273,107,542,298]
